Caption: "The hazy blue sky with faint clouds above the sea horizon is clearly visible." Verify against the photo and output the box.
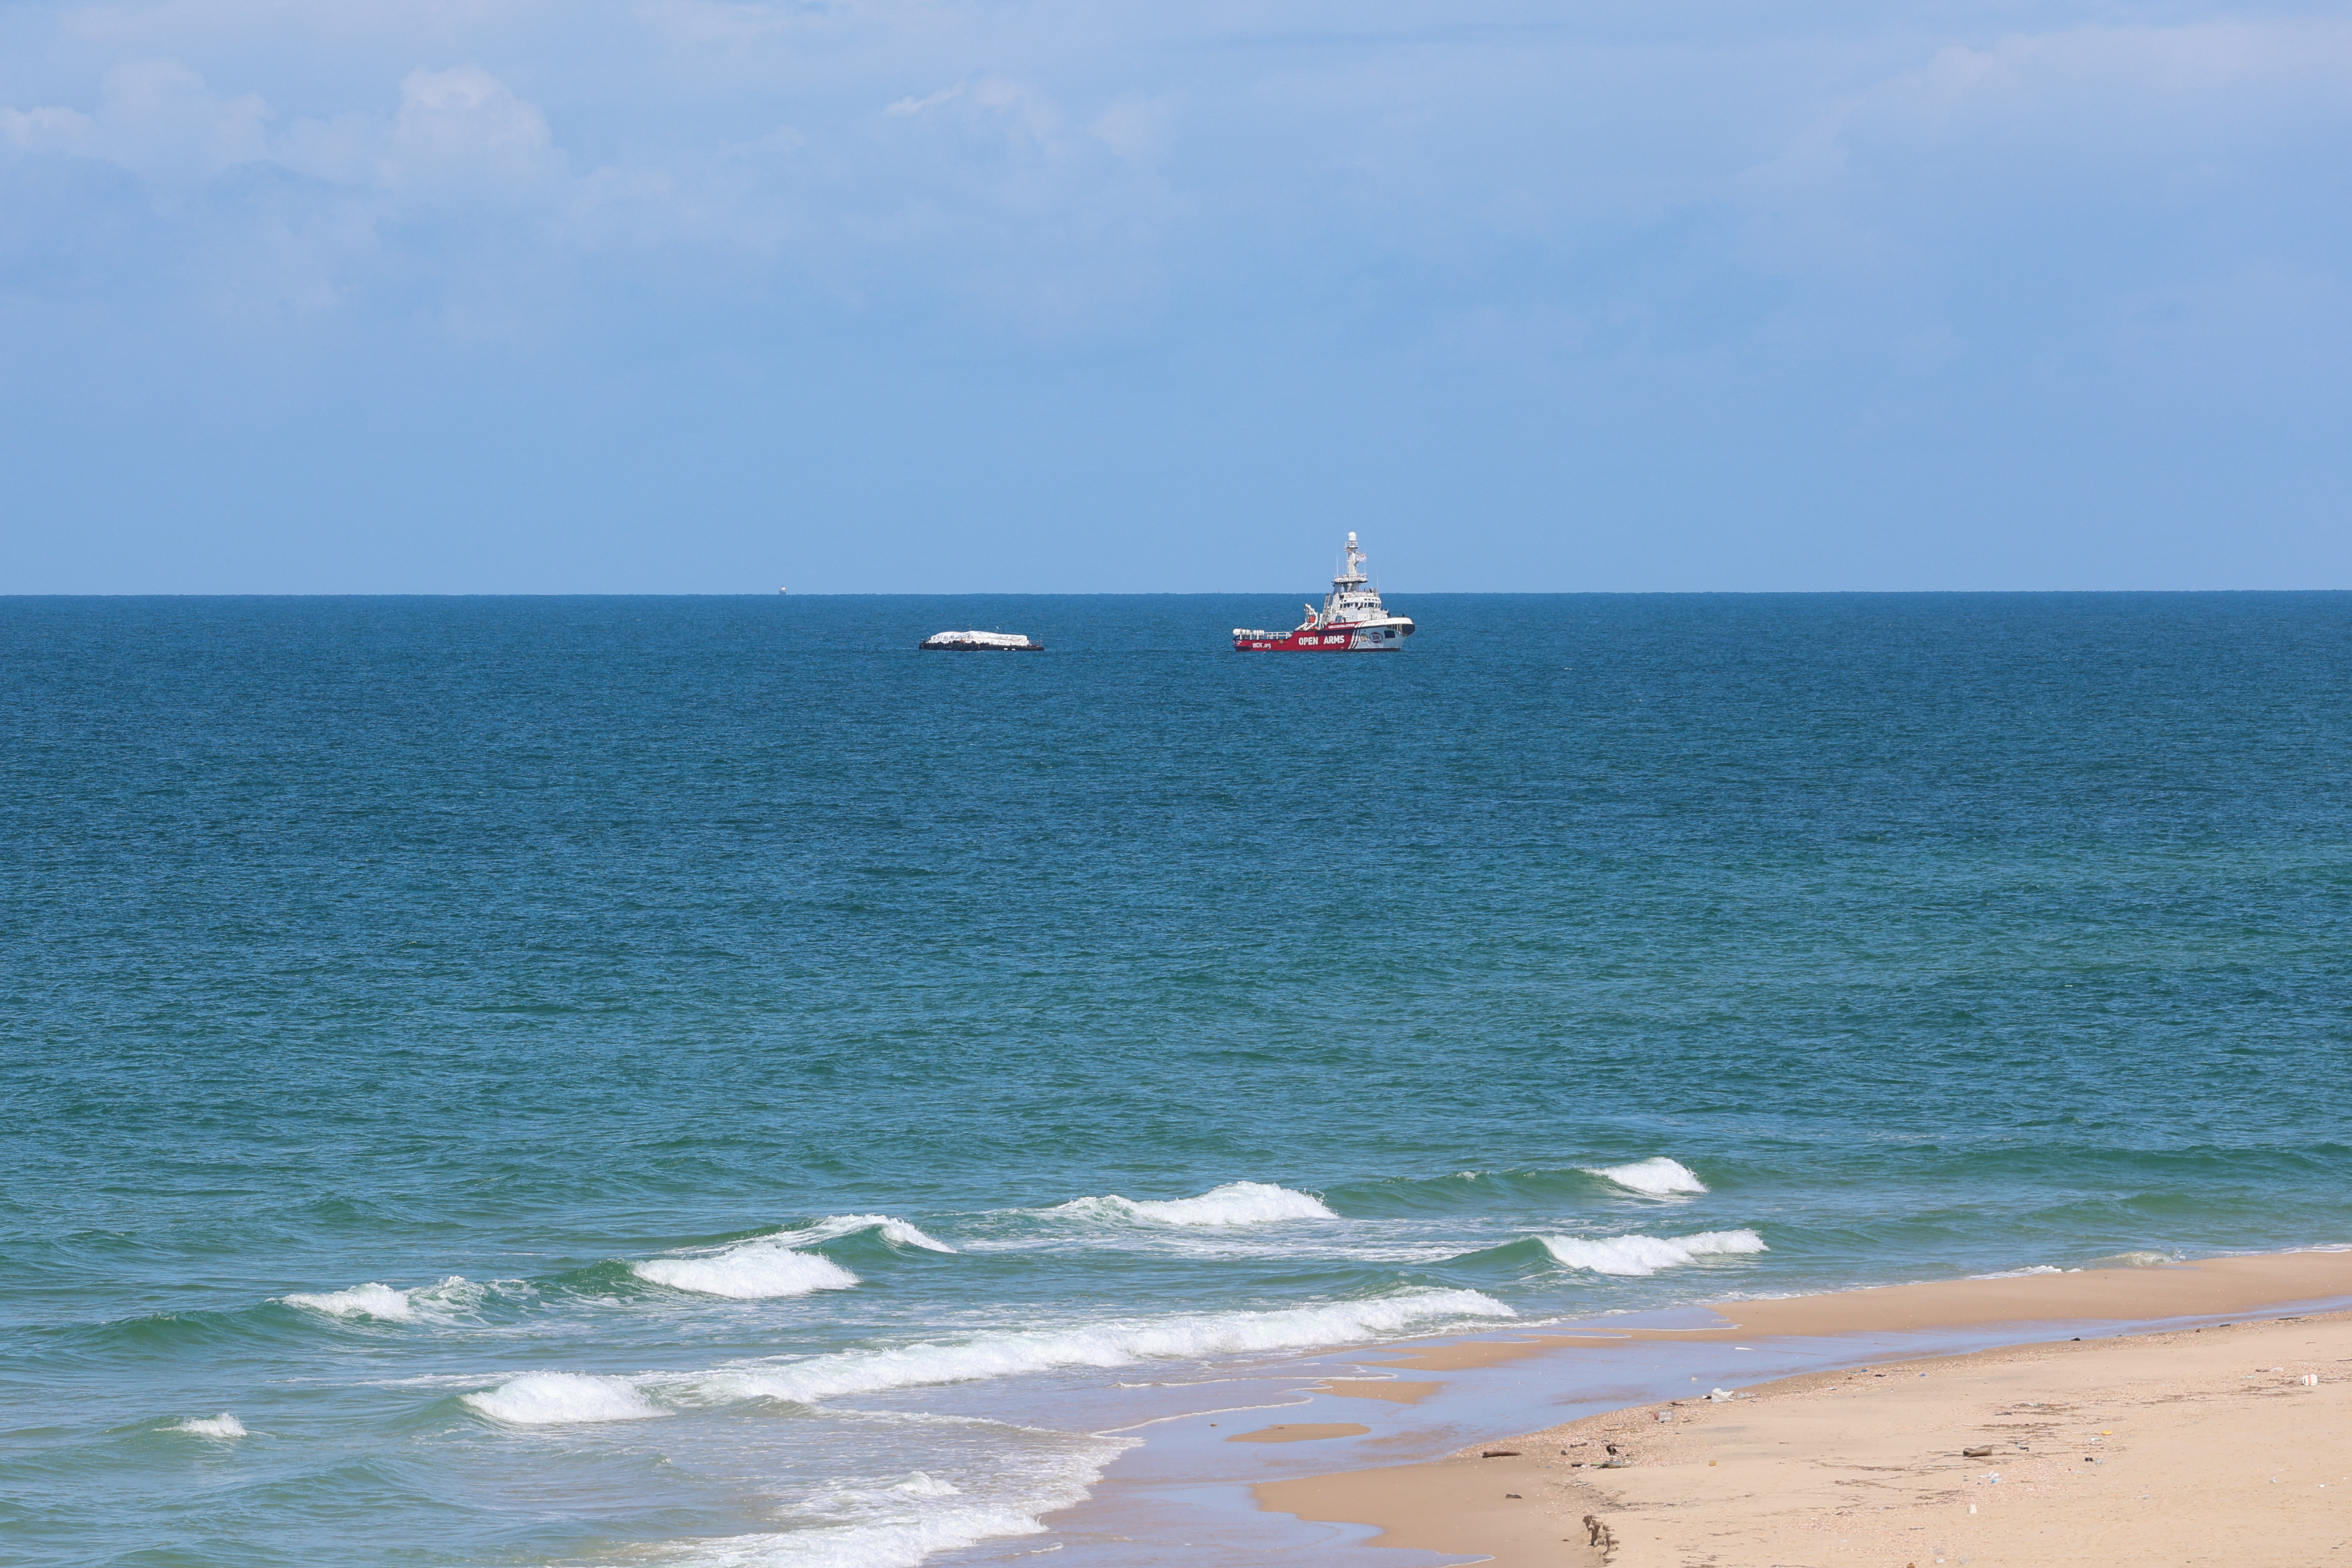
[0,0,2352,592]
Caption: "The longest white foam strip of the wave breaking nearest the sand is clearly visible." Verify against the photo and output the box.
[668,1291,1517,1404]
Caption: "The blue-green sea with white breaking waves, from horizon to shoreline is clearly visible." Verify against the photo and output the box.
[0,592,2352,1568]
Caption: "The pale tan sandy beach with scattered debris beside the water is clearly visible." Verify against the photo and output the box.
[1256,1253,2352,1568]
